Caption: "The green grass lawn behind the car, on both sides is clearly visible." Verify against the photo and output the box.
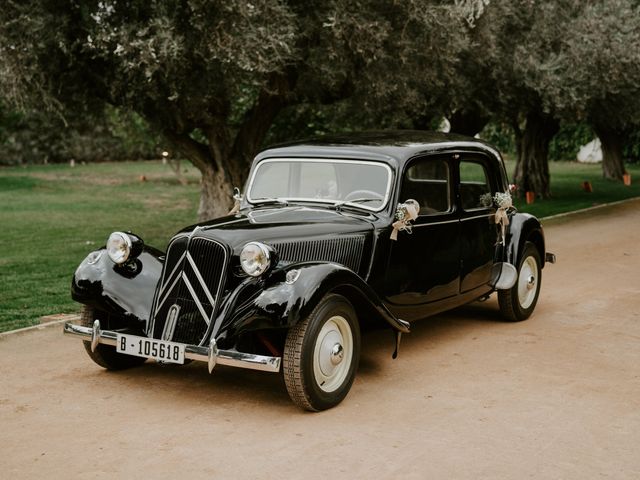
[0,161,640,331]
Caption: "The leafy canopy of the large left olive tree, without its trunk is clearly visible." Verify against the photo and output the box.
[0,0,470,148]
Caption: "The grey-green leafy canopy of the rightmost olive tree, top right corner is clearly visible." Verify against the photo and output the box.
[527,0,640,130]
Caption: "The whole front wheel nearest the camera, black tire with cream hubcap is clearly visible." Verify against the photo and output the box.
[282,294,360,412]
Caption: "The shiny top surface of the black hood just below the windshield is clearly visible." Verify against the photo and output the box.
[175,206,377,253]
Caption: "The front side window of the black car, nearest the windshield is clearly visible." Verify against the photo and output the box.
[401,157,451,215]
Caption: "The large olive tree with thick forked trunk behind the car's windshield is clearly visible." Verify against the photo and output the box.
[0,0,478,219]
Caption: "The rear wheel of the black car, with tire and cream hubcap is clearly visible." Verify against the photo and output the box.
[498,242,542,322]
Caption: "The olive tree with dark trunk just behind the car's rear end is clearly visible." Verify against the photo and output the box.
[449,0,576,197]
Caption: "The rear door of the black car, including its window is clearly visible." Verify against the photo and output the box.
[457,153,498,293]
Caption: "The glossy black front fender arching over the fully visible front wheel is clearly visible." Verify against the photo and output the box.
[219,263,409,342]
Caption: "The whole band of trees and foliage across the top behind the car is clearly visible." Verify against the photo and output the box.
[0,0,640,216]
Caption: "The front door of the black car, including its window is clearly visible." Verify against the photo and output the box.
[386,155,460,320]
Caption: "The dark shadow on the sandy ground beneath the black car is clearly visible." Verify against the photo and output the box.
[85,301,504,412]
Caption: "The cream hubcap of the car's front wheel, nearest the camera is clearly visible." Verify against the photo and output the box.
[313,315,353,392]
